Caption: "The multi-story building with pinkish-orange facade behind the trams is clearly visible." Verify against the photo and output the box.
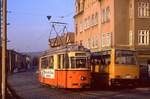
[74,0,150,65]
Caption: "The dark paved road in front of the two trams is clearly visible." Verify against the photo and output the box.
[8,72,150,99]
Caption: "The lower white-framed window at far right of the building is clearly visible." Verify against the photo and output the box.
[138,30,150,45]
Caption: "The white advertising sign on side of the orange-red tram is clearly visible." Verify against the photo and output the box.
[41,69,55,79]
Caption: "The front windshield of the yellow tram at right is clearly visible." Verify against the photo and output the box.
[115,50,136,65]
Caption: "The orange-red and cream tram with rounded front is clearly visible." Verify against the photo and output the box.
[39,46,91,88]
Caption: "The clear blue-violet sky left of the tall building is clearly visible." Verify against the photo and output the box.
[7,0,75,52]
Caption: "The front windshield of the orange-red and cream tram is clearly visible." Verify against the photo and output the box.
[71,57,87,68]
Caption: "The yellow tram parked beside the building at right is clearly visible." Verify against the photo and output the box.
[91,49,139,87]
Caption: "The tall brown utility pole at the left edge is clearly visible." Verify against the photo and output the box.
[1,0,7,99]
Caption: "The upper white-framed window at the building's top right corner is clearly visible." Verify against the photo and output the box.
[138,2,150,18]
